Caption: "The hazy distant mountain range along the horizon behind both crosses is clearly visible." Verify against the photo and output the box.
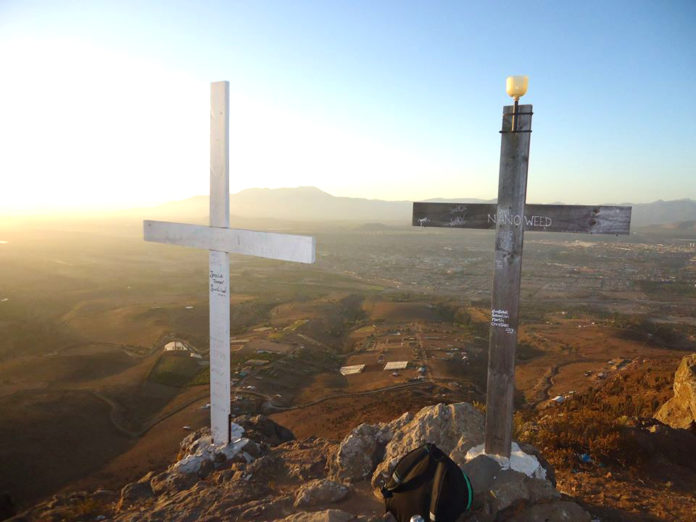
[147,187,696,229]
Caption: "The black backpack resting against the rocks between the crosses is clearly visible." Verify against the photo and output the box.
[382,443,474,522]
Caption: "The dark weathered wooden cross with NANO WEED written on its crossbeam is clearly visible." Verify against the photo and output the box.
[412,105,631,458]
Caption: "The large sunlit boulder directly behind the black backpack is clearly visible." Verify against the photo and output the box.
[372,402,484,490]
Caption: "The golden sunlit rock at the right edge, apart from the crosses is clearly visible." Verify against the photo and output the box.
[655,353,696,429]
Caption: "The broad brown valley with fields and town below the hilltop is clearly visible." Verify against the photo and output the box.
[0,214,696,511]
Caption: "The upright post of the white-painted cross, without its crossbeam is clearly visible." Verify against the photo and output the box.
[209,82,230,443]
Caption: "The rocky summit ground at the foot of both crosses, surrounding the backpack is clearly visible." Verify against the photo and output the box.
[5,403,590,522]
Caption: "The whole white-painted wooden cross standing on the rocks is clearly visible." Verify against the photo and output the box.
[143,82,315,444]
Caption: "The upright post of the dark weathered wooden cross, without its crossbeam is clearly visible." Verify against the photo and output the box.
[485,105,532,458]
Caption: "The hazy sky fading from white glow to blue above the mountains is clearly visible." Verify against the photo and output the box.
[0,0,696,213]
